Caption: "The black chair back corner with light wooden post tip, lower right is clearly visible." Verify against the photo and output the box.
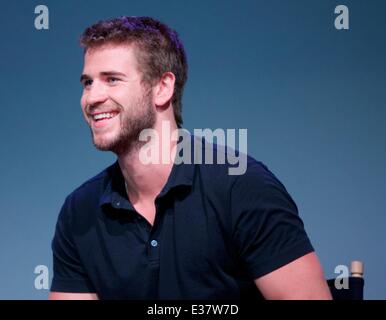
[327,261,365,300]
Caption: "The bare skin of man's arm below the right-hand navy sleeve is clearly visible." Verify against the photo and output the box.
[255,252,332,300]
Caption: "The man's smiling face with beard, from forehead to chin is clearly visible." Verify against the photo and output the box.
[81,45,156,155]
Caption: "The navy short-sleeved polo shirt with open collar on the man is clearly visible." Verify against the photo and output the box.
[51,138,313,299]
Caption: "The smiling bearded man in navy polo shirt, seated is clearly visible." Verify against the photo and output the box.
[50,17,331,299]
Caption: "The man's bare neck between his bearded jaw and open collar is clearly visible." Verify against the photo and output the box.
[118,120,177,204]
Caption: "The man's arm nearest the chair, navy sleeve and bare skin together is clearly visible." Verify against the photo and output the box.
[231,162,331,299]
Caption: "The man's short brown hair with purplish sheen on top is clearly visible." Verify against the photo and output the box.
[80,16,188,128]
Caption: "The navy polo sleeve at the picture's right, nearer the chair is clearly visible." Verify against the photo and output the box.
[231,162,314,279]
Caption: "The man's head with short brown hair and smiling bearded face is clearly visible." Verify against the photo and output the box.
[81,17,187,153]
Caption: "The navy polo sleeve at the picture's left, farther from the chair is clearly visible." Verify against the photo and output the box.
[51,196,95,293]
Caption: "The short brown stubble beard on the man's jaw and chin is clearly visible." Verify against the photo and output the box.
[90,93,156,156]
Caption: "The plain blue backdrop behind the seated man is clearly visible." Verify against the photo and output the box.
[0,0,386,299]
